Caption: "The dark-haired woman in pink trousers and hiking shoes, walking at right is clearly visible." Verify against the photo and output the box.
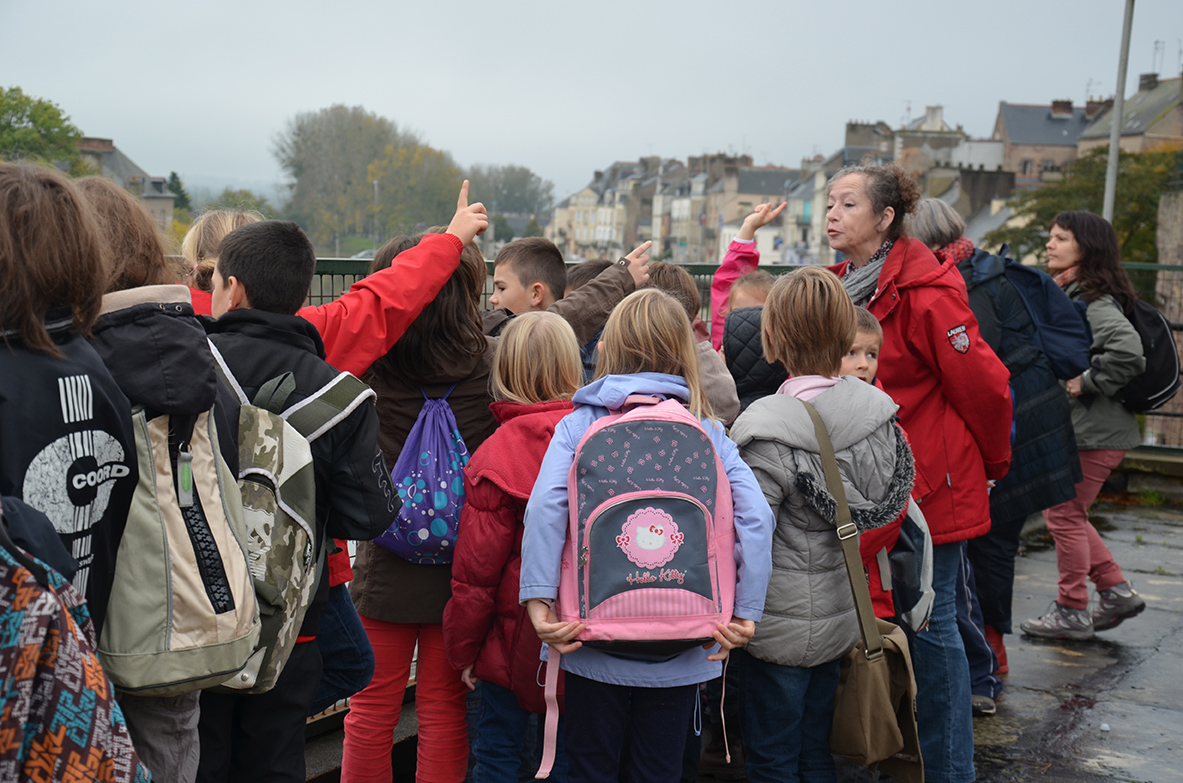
[1022,212,1146,640]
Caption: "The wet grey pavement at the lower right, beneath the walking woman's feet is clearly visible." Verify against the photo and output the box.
[974,497,1183,783]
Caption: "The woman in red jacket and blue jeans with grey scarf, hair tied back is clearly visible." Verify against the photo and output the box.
[826,166,1013,783]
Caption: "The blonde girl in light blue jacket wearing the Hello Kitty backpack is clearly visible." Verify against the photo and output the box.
[518,290,772,783]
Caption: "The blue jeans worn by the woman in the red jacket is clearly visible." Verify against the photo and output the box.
[904,542,975,783]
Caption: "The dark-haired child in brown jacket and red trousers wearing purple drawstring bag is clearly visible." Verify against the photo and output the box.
[341,229,497,782]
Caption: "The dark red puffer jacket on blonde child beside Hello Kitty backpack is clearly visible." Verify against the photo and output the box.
[444,400,573,713]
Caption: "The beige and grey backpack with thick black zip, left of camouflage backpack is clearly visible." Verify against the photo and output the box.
[98,406,259,695]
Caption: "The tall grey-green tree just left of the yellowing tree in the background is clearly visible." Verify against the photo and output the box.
[273,104,419,246]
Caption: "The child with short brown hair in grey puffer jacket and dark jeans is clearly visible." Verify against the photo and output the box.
[731,267,914,781]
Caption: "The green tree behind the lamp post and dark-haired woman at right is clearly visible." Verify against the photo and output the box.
[982,148,1179,264]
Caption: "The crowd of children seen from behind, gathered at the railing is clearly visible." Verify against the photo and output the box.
[0,163,913,782]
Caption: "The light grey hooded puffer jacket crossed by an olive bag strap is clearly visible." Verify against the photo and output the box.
[731,376,916,667]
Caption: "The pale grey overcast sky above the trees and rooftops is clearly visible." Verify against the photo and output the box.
[0,0,1183,199]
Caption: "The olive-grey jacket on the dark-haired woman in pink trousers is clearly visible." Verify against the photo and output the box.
[1064,280,1146,451]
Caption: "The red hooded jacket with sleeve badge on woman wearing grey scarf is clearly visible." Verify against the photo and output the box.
[830,238,1013,544]
